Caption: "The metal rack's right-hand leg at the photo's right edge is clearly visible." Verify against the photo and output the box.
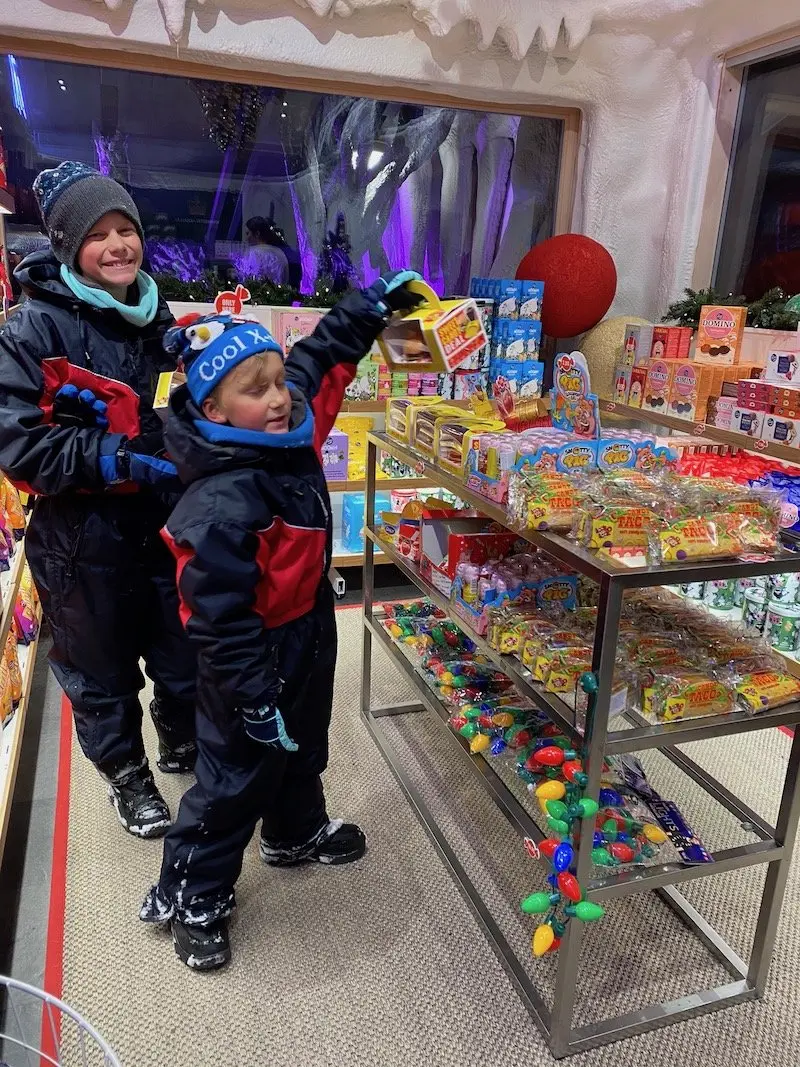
[748,729,800,997]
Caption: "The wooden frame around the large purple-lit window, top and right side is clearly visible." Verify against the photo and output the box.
[0,34,582,234]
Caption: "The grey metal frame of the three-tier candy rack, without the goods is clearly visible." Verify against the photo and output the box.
[362,433,800,1058]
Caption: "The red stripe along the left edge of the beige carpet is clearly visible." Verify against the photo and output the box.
[42,697,73,1062]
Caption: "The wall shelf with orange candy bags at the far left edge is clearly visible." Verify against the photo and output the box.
[0,479,42,861]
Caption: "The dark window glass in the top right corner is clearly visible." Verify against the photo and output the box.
[716,53,800,301]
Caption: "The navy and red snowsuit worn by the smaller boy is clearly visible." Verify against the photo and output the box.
[148,292,385,925]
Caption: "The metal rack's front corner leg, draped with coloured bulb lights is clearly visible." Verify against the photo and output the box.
[550,578,623,1058]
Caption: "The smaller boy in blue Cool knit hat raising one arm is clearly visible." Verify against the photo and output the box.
[141,271,418,970]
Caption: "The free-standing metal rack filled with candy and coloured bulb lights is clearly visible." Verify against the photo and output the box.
[362,422,800,1055]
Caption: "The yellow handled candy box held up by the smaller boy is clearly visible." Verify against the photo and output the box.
[378,282,489,373]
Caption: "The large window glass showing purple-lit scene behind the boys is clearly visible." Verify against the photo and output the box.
[0,55,563,302]
